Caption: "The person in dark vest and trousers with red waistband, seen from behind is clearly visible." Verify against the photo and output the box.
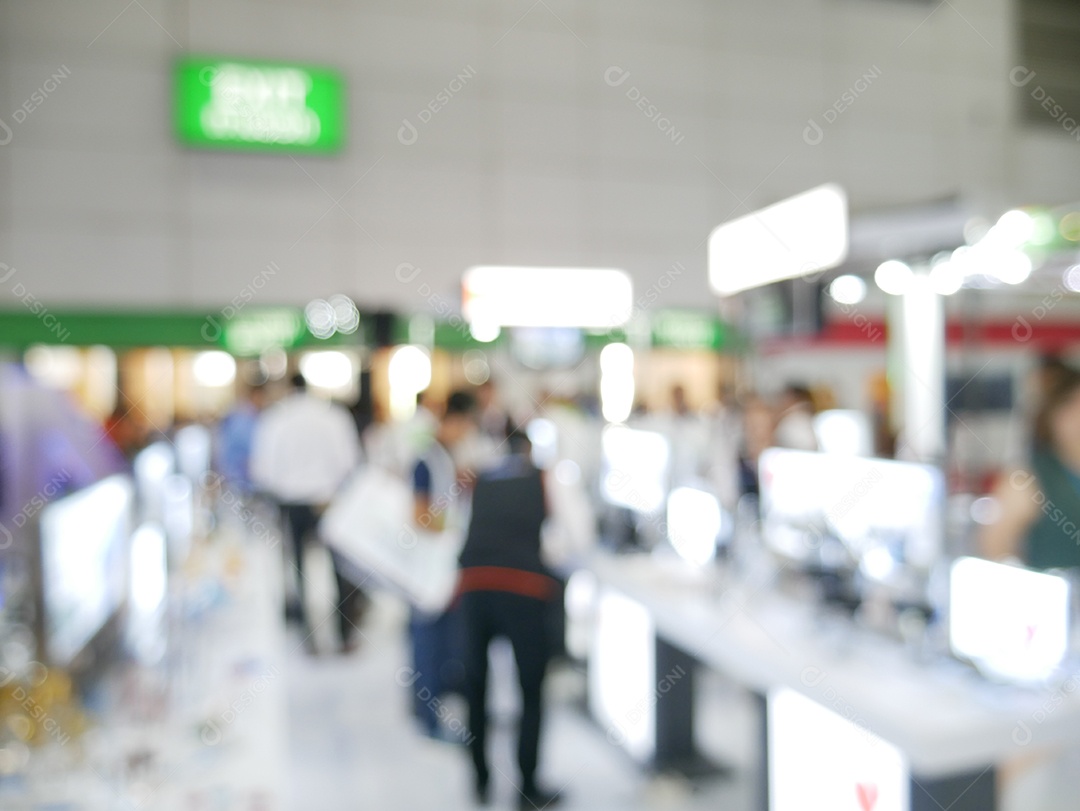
[459,432,562,811]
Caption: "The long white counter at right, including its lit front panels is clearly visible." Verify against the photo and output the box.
[590,555,1080,811]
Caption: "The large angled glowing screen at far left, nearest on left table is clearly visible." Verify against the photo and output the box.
[39,476,134,666]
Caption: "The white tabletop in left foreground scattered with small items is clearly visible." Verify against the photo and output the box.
[0,535,287,811]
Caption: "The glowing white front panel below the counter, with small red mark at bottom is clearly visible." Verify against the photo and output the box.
[768,688,910,811]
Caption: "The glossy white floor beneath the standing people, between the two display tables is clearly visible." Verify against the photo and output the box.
[287,546,754,811]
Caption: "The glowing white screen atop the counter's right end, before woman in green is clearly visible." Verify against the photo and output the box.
[949,557,1070,681]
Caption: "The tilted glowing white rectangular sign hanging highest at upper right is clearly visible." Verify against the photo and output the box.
[708,184,848,296]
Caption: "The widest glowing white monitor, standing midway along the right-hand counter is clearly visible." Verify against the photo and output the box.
[759,448,945,575]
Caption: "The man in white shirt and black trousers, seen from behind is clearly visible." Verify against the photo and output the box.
[251,374,363,649]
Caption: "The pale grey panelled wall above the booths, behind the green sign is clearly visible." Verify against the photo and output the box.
[0,0,1062,310]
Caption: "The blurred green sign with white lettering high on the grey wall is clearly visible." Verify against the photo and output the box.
[175,58,346,153]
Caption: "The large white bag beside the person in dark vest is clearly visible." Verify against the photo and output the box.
[320,465,464,612]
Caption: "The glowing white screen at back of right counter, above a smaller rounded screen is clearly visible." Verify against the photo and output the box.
[600,425,671,513]
